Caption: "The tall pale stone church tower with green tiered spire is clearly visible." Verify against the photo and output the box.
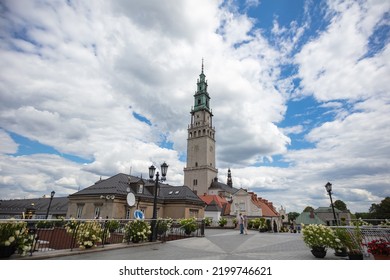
[184,60,218,195]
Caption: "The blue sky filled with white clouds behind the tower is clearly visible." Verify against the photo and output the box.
[0,0,390,213]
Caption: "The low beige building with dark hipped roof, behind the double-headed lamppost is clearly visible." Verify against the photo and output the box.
[67,173,205,219]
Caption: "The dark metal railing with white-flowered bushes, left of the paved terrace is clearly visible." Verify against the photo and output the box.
[0,219,205,258]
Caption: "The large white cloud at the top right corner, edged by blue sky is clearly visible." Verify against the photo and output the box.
[296,1,390,101]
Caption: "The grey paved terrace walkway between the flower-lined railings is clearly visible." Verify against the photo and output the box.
[18,229,360,260]
